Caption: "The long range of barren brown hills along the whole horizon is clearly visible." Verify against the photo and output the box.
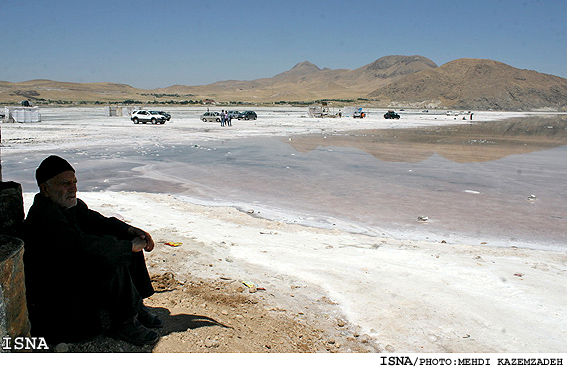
[0,55,567,110]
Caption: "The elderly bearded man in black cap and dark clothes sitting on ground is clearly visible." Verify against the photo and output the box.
[22,156,163,345]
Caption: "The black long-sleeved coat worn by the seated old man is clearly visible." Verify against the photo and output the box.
[22,194,139,337]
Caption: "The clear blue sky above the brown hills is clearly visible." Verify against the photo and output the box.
[0,0,567,88]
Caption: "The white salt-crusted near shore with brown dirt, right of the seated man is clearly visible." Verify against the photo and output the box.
[37,193,567,352]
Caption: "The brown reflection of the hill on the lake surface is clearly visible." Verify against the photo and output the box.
[285,116,567,163]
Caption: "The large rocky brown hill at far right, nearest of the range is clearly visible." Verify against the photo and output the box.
[369,59,567,110]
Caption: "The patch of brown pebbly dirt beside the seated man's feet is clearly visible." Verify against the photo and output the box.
[52,273,380,353]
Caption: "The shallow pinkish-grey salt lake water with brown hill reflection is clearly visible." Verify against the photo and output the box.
[3,118,567,250]
